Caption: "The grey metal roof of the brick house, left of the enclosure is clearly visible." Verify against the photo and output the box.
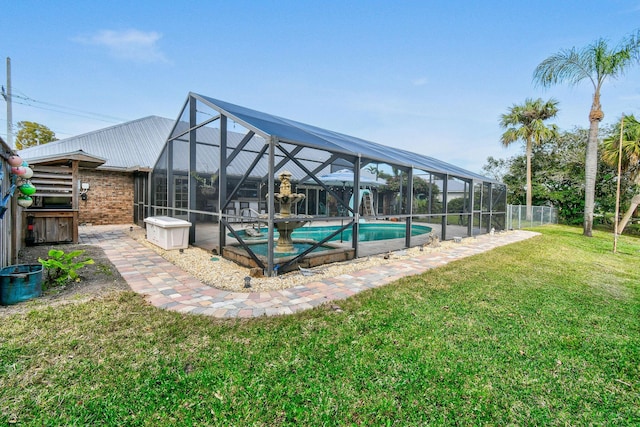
[20,116,175,171]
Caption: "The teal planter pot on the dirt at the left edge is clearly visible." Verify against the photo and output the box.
[0,264,43,305]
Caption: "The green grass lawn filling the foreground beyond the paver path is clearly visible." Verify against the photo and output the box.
[0,226,640,426]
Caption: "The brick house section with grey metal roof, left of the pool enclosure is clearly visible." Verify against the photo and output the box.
[19,116,174,232]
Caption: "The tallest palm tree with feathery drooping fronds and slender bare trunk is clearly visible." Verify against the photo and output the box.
[533,30,640,237]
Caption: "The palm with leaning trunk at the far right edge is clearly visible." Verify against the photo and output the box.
[602,116,640,234]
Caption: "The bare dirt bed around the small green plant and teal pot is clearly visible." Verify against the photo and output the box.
[0,245,131,317]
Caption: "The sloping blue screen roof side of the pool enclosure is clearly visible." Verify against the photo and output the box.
[195,93,497,182]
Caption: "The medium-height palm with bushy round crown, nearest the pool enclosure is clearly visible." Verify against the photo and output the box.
[500,98,558,219]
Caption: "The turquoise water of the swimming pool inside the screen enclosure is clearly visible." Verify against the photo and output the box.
[232,223,431,242]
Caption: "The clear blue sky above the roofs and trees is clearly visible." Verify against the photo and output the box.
[0,0,640,172]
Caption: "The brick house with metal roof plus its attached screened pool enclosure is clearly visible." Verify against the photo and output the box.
[15,92,506,274]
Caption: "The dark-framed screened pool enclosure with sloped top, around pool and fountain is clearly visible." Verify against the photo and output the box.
[148,93,506,275]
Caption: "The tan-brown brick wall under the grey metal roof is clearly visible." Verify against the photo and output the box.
[78,169,133,225]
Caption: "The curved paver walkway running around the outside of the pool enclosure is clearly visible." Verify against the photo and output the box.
[80,225,539,318]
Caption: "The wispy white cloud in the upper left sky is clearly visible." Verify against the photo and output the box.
[74,29,169,63]
